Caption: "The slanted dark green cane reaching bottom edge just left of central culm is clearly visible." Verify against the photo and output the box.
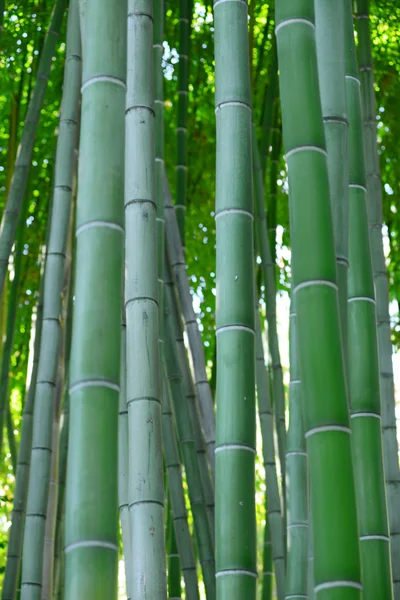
[165,295,215,600]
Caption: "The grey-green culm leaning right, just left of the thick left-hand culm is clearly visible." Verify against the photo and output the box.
[21,0,81,600]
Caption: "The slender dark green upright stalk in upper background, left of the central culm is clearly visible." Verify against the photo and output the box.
[175,0,192,247]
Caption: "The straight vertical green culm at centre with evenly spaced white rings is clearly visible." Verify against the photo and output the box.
[214,0,257,600]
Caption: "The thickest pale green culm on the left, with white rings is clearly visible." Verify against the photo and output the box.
[64,0,127,600]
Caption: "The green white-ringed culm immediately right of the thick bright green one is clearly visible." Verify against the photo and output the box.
[345,0,393,600]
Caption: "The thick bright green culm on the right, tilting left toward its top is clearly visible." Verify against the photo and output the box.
[275,0,362,600]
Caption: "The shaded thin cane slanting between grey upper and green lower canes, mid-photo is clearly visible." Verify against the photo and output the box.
[164,260,215,545]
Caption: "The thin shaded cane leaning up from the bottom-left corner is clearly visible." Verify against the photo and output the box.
[1,296,43,600]
